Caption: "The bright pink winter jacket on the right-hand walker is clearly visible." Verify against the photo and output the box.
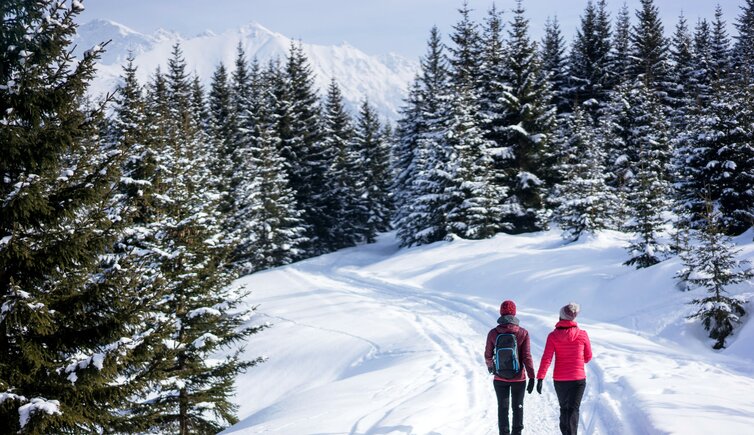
[537,320,592,381]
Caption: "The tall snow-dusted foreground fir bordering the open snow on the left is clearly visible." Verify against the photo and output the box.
[130,45,262,434]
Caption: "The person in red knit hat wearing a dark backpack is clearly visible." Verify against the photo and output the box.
[484,301,534,435]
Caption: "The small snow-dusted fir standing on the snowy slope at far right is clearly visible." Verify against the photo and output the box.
[676,199,754,349]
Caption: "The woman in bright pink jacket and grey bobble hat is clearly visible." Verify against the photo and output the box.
[537,302,592,435]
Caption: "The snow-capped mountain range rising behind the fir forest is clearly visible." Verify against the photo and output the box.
[74,20,419,121]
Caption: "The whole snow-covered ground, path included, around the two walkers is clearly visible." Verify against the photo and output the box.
[225,231,754,435]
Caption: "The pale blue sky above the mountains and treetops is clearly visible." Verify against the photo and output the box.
[80,0,744,58]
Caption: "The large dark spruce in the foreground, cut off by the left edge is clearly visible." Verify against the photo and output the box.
[0,0,157,433]
